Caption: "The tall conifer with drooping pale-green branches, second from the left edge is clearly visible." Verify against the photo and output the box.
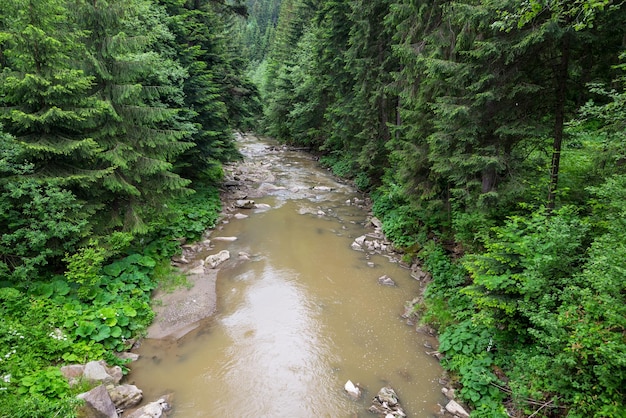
[75,0,193,233]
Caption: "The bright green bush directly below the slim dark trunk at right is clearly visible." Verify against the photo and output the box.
[464,208,588,339]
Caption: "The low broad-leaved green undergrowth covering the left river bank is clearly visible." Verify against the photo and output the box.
[0,186,220,418]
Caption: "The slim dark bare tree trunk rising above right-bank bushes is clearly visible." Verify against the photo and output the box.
[547,33,570,211]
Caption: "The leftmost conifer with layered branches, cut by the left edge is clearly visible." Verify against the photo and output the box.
[0,0,111,189]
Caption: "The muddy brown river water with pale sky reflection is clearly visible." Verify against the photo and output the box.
[127,136,442,418]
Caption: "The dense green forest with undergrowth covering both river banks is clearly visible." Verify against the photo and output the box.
[0,0,626,418]
